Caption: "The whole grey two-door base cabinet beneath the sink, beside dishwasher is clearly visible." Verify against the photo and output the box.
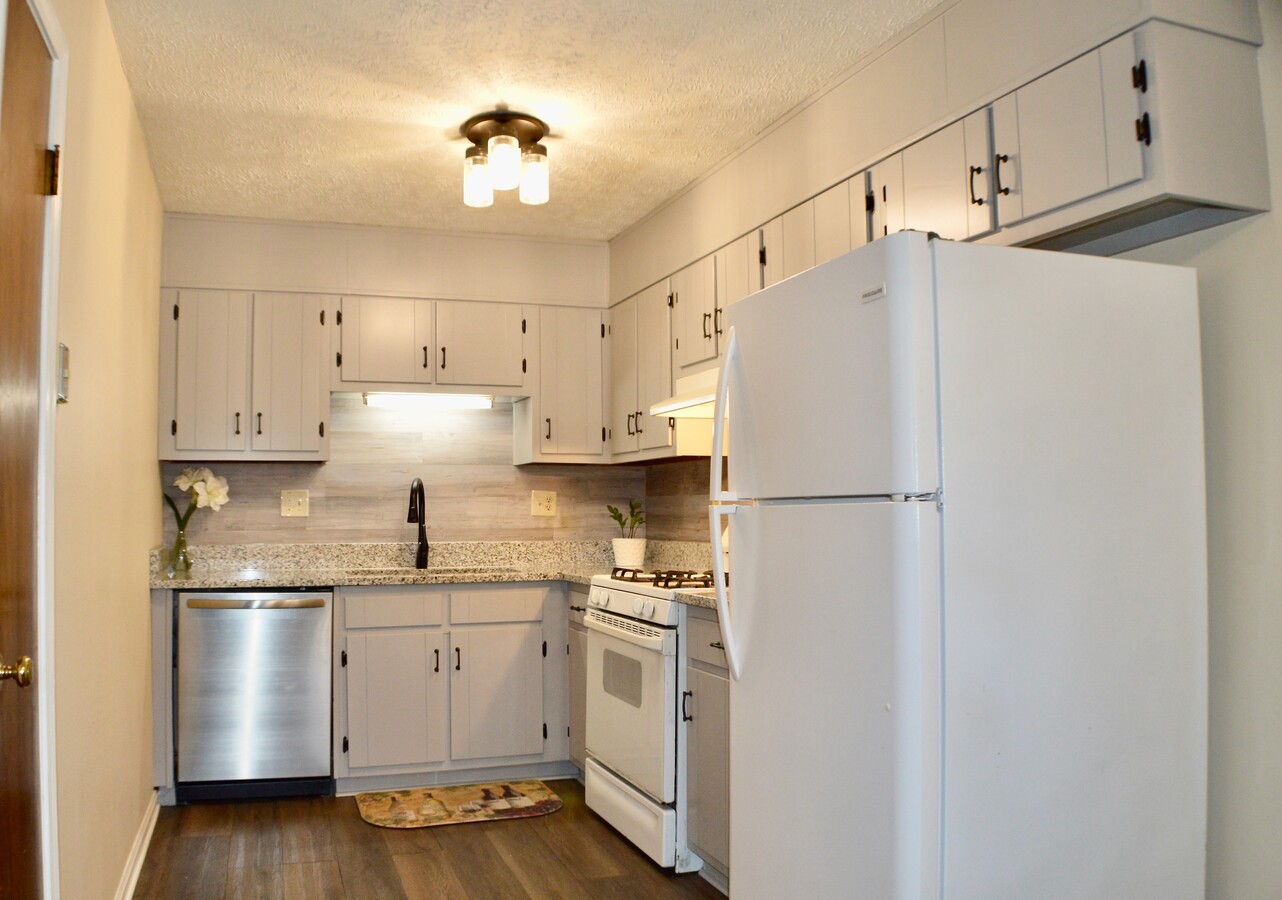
[335,585,568,778]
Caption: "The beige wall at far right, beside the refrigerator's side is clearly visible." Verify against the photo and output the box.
[1131,0,1282,900]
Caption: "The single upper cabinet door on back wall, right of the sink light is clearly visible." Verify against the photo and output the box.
[538,306,604,454]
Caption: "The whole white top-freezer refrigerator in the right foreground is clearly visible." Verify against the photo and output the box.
[709,232,1206,900]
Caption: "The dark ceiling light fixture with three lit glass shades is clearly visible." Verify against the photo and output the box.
[459,109,547,208]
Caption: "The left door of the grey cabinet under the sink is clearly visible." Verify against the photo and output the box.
[346,631,449,768]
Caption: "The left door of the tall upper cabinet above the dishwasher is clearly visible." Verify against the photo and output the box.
[174,291,250,450]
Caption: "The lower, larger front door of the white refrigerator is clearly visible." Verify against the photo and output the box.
[729,501,940,900]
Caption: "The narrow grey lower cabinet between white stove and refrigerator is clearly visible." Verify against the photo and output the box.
[686,606,729,877]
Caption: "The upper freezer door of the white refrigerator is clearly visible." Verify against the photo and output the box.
[723,232,938,499]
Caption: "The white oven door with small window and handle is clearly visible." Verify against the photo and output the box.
[583,609,677,804]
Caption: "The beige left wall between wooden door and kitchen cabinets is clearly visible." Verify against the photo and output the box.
[53,0,162,900]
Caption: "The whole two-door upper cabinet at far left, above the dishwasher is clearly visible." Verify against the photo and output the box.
[159,290,333,462]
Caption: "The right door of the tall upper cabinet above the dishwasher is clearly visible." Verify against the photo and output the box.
[250,294,329,451]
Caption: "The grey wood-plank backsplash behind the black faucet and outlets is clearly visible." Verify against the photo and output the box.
[162,394,708,544]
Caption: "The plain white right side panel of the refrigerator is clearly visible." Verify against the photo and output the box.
[928,244,1206,900]
